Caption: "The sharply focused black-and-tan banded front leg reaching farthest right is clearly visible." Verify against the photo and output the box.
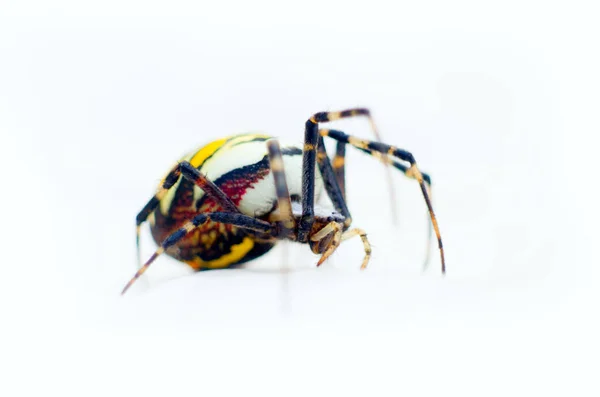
[318,127,446,273]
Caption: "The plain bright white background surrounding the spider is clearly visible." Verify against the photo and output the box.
[0,1,600,396]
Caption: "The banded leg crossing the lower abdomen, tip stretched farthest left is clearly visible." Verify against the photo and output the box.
[121,212,273,295]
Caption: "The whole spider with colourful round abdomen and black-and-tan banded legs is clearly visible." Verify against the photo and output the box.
[122,108,446,294]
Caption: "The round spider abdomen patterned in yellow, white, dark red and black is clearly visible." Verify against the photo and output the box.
[149,134,326,270]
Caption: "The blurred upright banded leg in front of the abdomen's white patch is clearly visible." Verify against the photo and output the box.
[267,139,295,235]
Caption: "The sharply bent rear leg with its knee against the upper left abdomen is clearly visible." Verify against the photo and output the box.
[135,161,240,268]
